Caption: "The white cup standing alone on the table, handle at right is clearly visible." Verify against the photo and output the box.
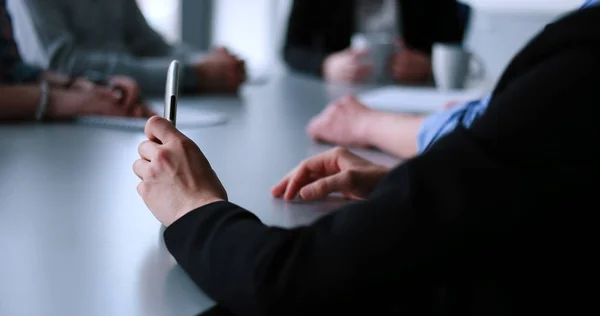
[432,43,485,90]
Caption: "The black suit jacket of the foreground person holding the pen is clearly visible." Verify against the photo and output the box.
[165,8,600,315]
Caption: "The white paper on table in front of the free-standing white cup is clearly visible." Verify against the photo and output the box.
[358,86,487,113]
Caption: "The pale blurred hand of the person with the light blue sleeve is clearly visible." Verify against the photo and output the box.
[307,96,374,147]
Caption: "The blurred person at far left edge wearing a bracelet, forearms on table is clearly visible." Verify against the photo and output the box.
[0,0,153,120]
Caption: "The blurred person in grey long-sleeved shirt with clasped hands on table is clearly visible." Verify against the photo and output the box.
[15,0,246,94]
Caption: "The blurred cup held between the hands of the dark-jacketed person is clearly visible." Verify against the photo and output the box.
[351,33,397,83]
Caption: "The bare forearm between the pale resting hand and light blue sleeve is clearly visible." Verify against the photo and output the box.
[363,111,425,158]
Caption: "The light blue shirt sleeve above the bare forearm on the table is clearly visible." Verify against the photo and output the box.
[417,95,491,154]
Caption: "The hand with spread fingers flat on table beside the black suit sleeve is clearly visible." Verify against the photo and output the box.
[271,147,389,200]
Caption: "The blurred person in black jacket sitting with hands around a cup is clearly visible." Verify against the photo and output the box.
[283,0,466,83]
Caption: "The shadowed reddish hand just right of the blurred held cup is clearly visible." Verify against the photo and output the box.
[390,40,431,84]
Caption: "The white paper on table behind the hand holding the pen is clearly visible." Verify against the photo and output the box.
[75,104,227,130]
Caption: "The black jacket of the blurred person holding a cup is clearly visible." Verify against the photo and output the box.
[283,0,465,76]
